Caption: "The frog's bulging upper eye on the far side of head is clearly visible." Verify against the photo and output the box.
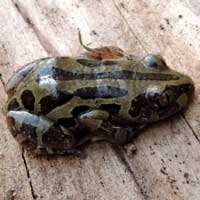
[144,55,168,70]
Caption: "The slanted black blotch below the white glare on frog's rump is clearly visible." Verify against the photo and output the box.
[40,90,73,114]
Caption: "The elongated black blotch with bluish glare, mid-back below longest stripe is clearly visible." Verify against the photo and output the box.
[74,86,128,99]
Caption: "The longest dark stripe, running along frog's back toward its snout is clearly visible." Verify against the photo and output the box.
[53,68,179,81]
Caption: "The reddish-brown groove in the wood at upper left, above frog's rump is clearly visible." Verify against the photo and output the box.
[11,0,60,56]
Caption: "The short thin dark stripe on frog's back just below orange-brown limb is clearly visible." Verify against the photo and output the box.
[76,59,117,67]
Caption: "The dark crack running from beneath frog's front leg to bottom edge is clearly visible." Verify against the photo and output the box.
[111,144,147,200]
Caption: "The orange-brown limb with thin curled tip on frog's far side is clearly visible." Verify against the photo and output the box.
[78,28,124,59]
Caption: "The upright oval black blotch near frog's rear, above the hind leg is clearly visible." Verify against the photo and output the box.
[21,90,35,111]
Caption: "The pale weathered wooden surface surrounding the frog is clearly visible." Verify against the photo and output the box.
[0,0,200,200]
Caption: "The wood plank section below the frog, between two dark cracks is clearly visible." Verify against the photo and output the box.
[23,144,143,200]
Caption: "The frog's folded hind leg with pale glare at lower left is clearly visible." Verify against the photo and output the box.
[7,111,79,155]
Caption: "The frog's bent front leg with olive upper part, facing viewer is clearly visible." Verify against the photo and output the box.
[79,109,145,145]
